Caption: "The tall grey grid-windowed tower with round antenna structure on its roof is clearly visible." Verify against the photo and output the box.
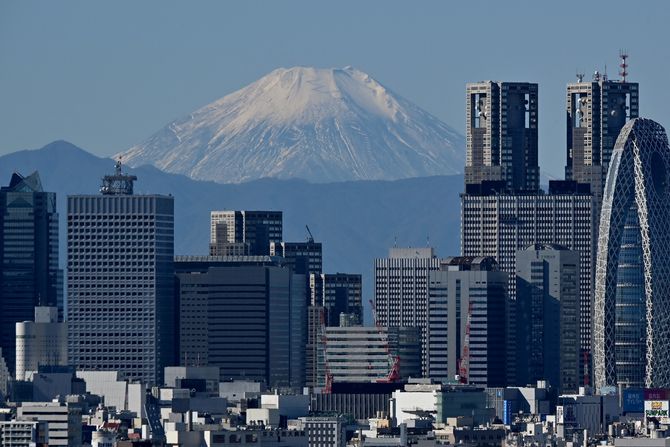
[67,162,174,384]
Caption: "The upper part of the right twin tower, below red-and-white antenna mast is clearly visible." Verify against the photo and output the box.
[565,71,639,204]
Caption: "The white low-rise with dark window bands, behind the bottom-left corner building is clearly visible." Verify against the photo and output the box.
[16,402,82,447]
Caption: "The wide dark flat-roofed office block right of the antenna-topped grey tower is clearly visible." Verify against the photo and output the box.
[174,256,307,389]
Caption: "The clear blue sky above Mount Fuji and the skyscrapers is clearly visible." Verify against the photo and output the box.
[0,0,670,175]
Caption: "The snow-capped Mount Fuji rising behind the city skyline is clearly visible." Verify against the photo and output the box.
[117,67,465,183]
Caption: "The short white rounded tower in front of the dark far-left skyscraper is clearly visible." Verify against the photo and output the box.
[16,307,67,380]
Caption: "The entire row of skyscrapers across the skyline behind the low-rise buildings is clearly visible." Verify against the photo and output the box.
[0,57,670,412]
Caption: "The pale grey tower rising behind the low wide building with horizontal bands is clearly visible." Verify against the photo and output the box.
[374,247,440,374]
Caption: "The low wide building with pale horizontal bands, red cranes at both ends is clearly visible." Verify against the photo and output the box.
[318,326,421,386]
